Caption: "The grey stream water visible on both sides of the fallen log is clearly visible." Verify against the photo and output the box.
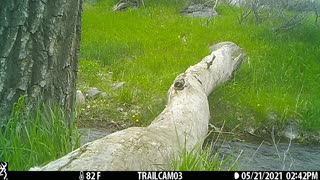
[80,128,320,171]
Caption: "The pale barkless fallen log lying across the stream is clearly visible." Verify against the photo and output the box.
[31,42,244,171]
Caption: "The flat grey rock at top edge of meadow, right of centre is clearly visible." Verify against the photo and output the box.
[180,4,218,17]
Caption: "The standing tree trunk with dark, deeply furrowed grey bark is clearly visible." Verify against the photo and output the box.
[0,0,82,123]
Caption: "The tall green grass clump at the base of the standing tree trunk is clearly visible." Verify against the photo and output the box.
[0,97,79,171]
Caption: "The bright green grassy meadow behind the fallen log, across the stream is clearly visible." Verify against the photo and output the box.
[79,0,320,138]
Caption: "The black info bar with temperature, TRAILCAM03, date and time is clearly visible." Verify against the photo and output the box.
[5,171,319,180]
